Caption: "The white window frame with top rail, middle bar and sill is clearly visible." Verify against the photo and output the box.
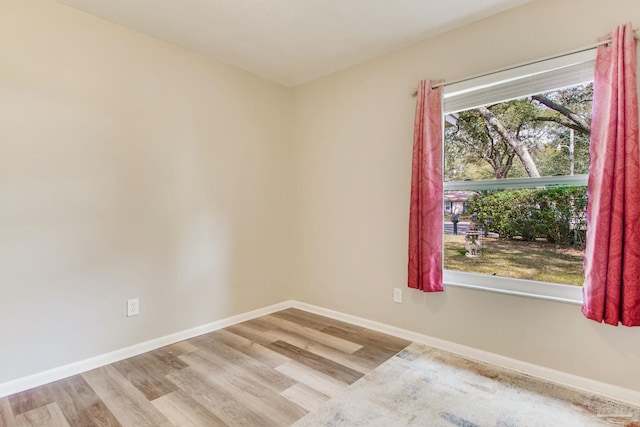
[443,49,596,304]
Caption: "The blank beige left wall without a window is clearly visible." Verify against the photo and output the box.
[0,0,291,383]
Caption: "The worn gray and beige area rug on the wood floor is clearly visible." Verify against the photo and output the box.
[294,343,640,427]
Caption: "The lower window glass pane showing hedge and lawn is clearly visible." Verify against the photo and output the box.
[444,186,587,286]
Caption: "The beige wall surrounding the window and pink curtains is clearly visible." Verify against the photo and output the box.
[292,0,640,390]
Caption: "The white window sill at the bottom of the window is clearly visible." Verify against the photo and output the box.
[444,270,582,305]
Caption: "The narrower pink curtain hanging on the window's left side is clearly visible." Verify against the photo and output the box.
[408,80,444,292]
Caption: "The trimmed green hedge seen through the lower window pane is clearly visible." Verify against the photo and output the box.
[469,187,587,245]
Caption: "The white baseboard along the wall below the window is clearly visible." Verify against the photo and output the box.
[292,301,640,406]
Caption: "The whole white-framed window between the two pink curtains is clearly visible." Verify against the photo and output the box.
[443,50,595,302]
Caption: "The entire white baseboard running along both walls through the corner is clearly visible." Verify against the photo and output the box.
[5,301,640,406]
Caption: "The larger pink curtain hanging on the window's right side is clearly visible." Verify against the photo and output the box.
[582,24,640,326]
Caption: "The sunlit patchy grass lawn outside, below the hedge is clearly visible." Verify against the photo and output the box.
[444,234,584,286]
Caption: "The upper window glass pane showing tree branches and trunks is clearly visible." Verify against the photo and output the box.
[444,83,593,181]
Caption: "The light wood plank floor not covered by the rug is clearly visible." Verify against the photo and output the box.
[0,309,409,427]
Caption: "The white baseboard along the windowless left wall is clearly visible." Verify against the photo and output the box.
[0,301,293,398]
